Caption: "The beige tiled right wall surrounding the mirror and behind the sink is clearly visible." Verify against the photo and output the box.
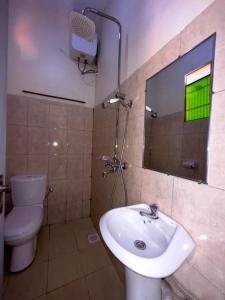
[91,0,225,300]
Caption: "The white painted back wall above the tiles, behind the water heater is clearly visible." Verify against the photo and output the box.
[8,0,95,106]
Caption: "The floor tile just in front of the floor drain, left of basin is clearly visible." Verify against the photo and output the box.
[80,242,111,274]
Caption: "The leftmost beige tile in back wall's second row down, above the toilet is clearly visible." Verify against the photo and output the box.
[6,125,28,155]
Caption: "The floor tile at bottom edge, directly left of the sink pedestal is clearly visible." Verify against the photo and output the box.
[86,266,125,300]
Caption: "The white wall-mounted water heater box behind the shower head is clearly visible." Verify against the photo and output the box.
[70,33,98,65]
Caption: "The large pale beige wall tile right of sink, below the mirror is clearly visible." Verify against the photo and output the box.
[172,178,225,289]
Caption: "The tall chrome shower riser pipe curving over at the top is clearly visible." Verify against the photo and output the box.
[82,7,122,158]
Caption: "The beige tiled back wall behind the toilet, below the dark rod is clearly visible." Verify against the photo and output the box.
[7,95,93,224]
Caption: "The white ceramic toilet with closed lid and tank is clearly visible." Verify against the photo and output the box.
[4,175,46,272]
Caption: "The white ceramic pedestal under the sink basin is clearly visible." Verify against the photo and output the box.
[125,266,161,300]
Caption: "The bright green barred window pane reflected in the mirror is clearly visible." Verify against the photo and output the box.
[185,75,211,121]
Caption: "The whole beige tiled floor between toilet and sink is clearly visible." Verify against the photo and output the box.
[4,219,125,300]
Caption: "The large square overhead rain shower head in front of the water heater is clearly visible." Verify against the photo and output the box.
[69,10,95,41]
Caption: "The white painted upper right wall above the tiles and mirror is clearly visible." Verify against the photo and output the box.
[96,0,214,104]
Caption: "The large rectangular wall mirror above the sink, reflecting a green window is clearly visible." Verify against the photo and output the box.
[143,35,215,183]
